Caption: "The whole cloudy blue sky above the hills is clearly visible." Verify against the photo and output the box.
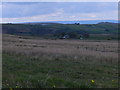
[0,2,118,23]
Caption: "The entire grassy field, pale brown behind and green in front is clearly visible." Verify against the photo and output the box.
[2,35,118,88]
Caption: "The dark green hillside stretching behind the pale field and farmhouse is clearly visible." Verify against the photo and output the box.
[2,22,118,38]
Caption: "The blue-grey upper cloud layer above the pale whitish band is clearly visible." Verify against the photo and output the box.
[3,2,118,18]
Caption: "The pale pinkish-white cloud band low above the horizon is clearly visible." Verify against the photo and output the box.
[2,9,117,22]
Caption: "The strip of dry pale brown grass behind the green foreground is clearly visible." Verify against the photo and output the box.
[3,35,118,62]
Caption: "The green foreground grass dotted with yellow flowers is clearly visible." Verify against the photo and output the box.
[2,53,118,88]
